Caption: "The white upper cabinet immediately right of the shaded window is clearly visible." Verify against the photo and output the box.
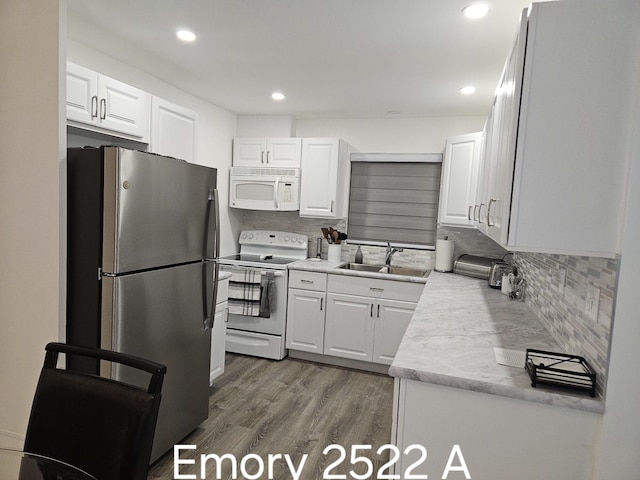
[438,132,482,227]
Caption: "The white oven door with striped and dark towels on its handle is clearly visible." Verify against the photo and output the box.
[220,265,287,335]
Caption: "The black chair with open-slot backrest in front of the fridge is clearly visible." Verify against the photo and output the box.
[24,343,167,480]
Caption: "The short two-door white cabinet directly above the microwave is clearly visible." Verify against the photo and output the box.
[233,137,302,168]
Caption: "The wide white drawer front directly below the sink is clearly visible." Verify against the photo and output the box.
[327,275,424,302]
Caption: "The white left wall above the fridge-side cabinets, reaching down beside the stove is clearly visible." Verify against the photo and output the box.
[67,39,241,255]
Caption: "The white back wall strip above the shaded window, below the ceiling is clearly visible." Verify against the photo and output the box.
[296,116,488,153]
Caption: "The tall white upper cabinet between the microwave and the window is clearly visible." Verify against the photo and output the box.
[300,138,350,218]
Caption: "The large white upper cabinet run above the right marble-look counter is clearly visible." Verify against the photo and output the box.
[475,0,638,257]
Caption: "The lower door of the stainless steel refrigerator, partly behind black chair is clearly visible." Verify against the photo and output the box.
[101,262,215,461]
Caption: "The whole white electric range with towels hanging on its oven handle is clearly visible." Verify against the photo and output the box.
[218,230,308,360]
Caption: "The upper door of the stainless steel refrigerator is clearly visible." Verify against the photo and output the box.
[102,147,217,273]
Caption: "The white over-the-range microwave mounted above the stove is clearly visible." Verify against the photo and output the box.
[229,174,300,211]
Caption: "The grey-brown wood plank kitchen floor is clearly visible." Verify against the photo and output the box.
[148,354,393,480]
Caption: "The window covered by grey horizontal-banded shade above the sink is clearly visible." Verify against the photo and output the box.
[347,154,442,249]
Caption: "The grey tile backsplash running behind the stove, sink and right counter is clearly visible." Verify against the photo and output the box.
[242,210,619,395]
